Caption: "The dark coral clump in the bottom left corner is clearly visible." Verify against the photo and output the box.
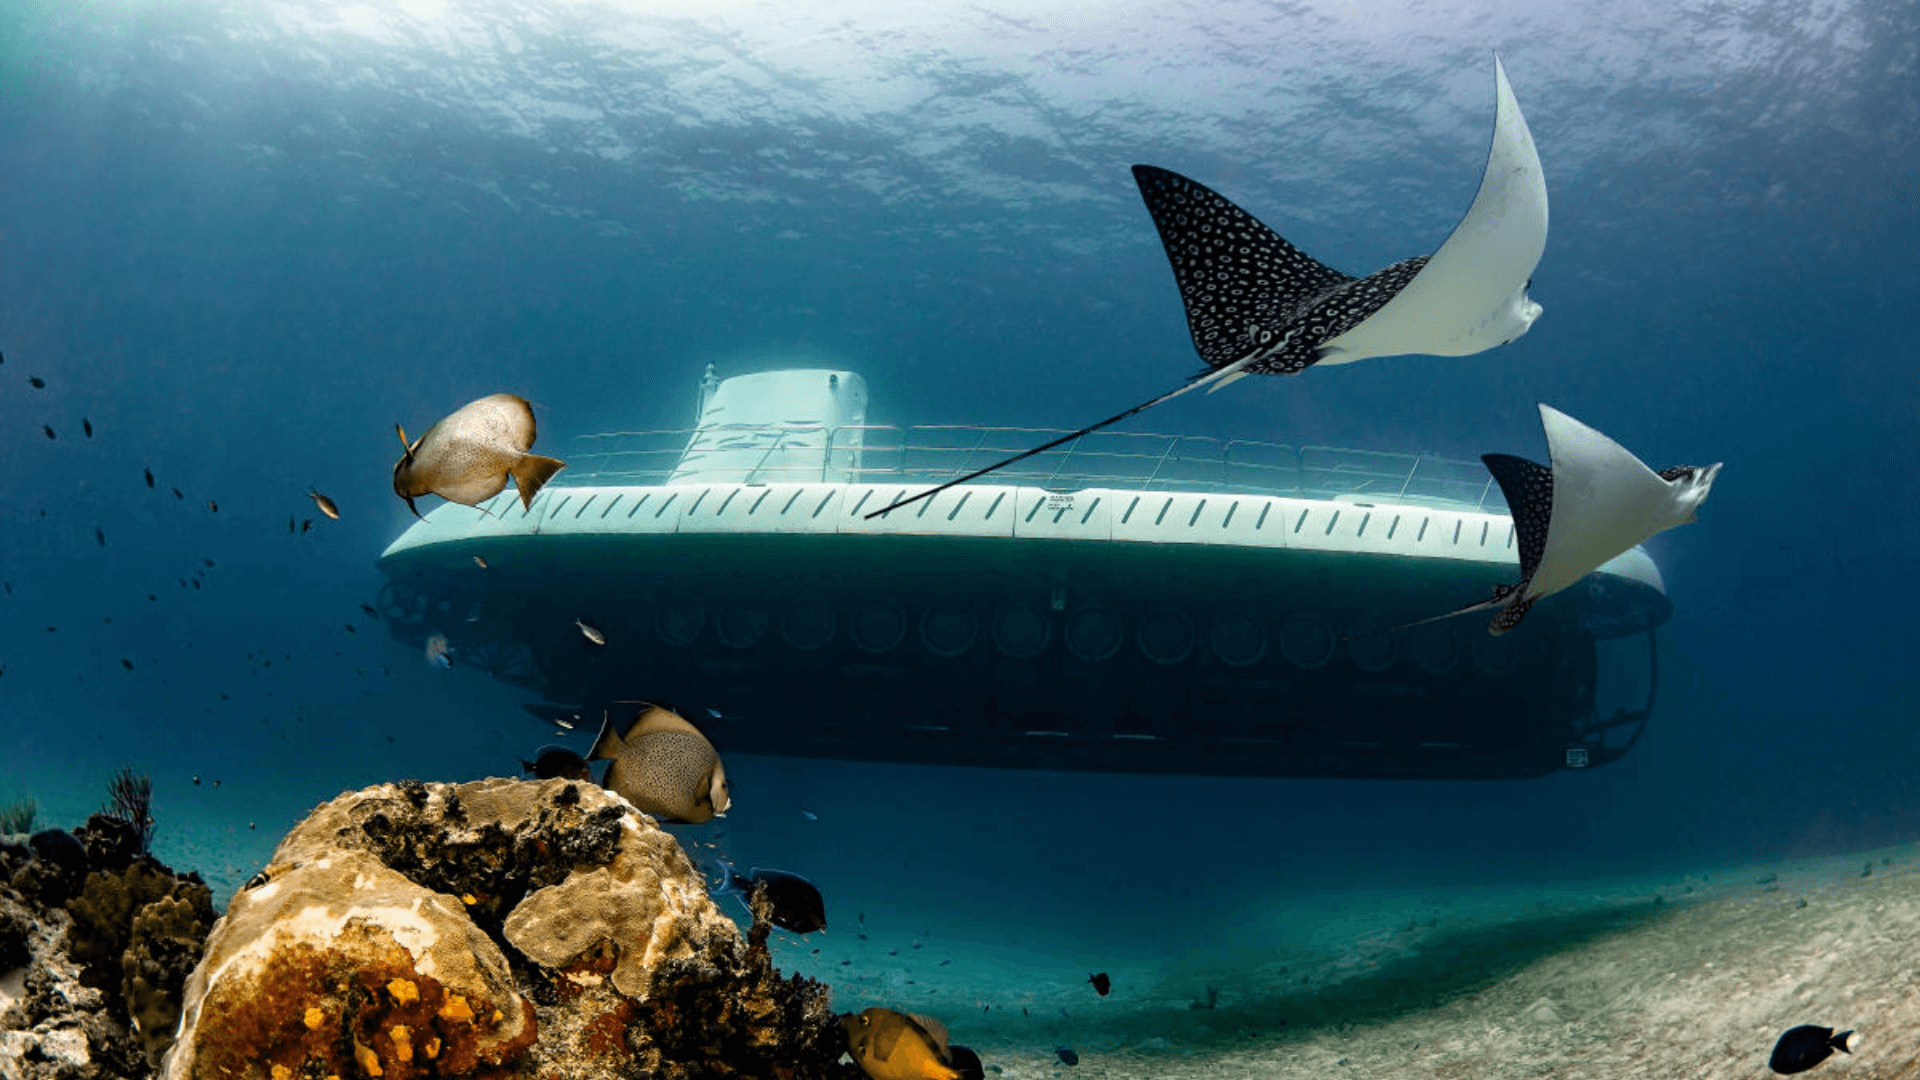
[0,815,213,1080]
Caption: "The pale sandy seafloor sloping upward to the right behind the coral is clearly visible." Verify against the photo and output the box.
[15,734,1920,1080]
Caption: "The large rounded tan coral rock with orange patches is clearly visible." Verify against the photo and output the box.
[168,778,860,1080]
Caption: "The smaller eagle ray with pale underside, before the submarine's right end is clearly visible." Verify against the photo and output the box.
[1420,405,1720,636]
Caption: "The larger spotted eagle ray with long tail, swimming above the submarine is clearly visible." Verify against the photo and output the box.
[866,56,1548,519]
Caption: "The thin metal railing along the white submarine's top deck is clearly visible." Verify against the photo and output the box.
[555,425,1505,513]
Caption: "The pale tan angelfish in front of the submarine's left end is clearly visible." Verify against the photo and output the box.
[394,394,566,517]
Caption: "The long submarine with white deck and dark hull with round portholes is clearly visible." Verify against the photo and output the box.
[378,365,1672,778]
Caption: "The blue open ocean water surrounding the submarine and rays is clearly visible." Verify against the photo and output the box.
[0,0,1920,1068]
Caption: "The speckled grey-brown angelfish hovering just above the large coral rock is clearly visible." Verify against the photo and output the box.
[588,701,733,824]
